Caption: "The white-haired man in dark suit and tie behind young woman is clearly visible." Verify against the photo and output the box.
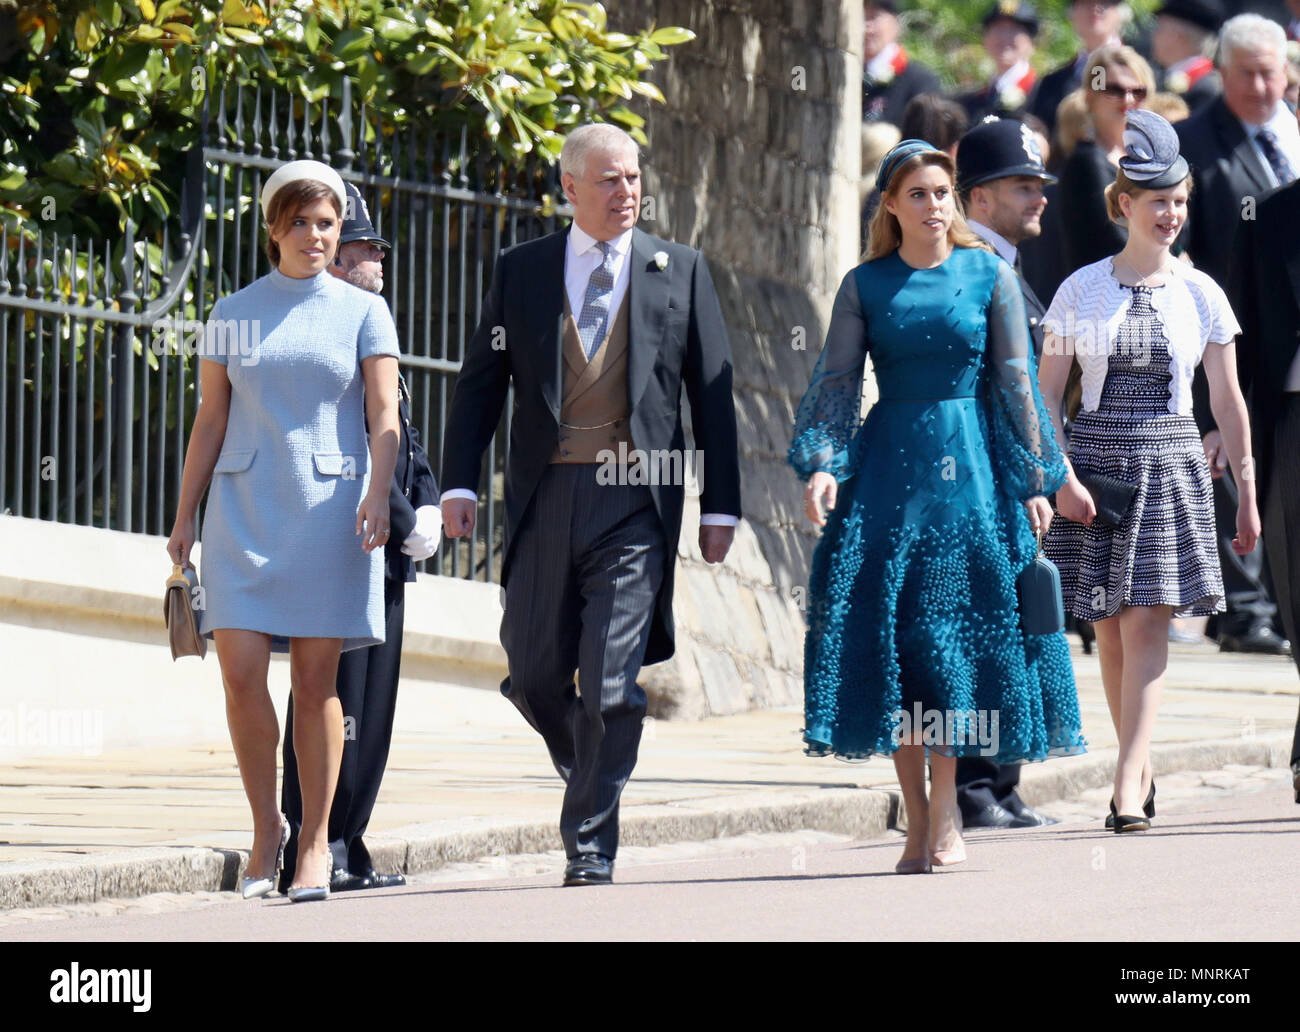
[1174,14,1300,655]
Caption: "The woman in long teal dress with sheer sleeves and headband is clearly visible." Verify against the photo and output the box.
[789,140,1086,873]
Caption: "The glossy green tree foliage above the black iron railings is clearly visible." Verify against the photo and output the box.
[0,0,693,234]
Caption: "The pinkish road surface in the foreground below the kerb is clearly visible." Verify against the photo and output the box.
[0,769,1300,941]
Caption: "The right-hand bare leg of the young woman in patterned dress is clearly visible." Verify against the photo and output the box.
[1115,606,1174,815]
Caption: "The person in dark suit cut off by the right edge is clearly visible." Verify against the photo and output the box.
[1227,181,1300,803]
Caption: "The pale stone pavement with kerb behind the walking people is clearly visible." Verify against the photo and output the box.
[0,642,1297,909]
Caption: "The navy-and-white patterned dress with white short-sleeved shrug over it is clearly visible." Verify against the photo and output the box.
[1044,259,1238,620]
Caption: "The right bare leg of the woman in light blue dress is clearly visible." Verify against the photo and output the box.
[289,638,343,888]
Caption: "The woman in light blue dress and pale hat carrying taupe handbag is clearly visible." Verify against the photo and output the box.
[168,161,398,901]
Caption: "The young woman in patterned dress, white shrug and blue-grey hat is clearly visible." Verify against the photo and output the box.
[1039,110,1260,832]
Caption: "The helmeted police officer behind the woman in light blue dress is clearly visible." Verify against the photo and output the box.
[280,183,442,892]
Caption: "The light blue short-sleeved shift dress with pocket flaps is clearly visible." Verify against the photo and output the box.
[200,269,398,652]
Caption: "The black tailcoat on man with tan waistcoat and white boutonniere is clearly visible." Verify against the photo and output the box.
[442,229,740,664]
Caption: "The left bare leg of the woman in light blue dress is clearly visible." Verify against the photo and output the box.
[213,629,282,877]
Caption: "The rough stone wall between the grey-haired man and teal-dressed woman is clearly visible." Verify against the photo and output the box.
[606,0,862,717]
